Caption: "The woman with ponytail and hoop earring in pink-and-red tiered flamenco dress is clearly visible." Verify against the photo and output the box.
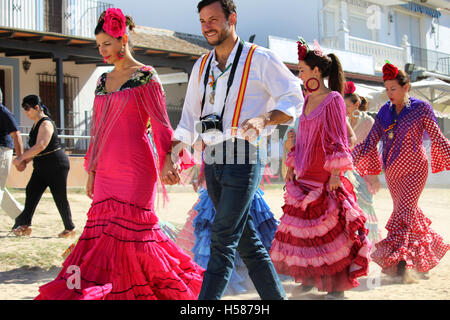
[270,39,370,299]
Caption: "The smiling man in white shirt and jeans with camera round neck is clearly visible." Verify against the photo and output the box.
[162,0,303,300]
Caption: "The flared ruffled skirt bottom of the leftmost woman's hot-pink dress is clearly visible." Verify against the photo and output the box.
[36,199,204,300]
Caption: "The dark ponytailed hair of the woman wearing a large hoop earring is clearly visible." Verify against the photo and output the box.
[303,50,345,95]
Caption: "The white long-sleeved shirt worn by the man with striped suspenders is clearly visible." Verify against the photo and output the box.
[174,39,303,145]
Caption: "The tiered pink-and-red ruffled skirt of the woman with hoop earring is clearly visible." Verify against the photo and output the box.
[270,178,371,291]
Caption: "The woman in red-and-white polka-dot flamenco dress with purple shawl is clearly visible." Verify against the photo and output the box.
[352,63,450,284]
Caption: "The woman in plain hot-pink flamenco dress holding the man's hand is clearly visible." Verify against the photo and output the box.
[36,9,204,300]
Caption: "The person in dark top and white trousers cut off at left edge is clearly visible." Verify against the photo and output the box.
[0,89,25,219]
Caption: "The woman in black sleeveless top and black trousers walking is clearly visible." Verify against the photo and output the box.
[13,95,75,238]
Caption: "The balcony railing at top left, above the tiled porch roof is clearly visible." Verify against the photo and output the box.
[0,0,112,38]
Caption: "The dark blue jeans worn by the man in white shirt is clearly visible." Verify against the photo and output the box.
[198,142,286,300]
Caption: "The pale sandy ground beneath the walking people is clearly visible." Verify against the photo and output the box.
[0,185,450,300]
